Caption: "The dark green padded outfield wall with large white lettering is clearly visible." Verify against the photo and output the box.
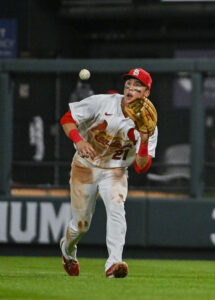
[0,197,215,248]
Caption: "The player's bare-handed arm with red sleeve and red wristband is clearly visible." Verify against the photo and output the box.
[60,111,97,159]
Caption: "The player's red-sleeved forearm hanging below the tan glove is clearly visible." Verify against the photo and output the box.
[134,132,152,173]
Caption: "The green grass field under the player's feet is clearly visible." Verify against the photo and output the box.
[0,256,215,300]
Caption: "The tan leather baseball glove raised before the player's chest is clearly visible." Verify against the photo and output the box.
[125,98,157,136]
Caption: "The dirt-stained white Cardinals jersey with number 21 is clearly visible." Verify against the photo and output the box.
[69,94,158,168]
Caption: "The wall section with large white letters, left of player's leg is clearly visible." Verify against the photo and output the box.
[0,201,71,244]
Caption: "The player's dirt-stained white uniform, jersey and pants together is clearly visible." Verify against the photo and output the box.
[62,94,158,270]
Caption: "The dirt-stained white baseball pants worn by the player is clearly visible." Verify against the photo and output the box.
[62,156,128,270]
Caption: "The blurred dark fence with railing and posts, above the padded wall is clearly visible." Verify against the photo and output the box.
[0,59,215,197]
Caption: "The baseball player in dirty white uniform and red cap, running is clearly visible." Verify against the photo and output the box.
[60,68,158,278]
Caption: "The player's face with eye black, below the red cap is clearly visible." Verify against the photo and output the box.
[124,78,150,105]
